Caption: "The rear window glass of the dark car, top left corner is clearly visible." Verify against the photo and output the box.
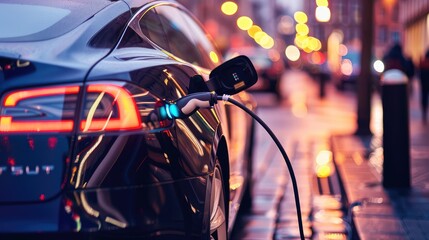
[0,0,115,42]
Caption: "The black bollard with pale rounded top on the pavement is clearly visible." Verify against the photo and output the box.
[381,69,410,188]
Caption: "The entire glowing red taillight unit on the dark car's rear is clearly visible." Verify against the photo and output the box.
[0,84,142,133]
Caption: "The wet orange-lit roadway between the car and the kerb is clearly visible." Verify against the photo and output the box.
[232,71,360,239]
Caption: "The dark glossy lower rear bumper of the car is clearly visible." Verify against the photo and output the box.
[0,176,208,239]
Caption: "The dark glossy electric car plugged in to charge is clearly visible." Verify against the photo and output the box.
[0,0,255,239]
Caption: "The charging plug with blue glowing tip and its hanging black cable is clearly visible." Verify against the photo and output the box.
[161,92,304,240]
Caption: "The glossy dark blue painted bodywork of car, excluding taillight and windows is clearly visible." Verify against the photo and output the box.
[0,0,253,239]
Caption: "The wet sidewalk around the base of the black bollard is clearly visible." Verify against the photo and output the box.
[330,86,429,239]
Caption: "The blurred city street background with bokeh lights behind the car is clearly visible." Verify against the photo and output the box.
[179,0,429,239]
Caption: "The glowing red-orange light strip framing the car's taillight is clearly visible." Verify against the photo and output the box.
[0,84,142,133]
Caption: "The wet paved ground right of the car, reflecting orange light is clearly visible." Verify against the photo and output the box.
[232,72,429,240]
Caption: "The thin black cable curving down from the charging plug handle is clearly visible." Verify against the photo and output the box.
[217,95,304,240]
